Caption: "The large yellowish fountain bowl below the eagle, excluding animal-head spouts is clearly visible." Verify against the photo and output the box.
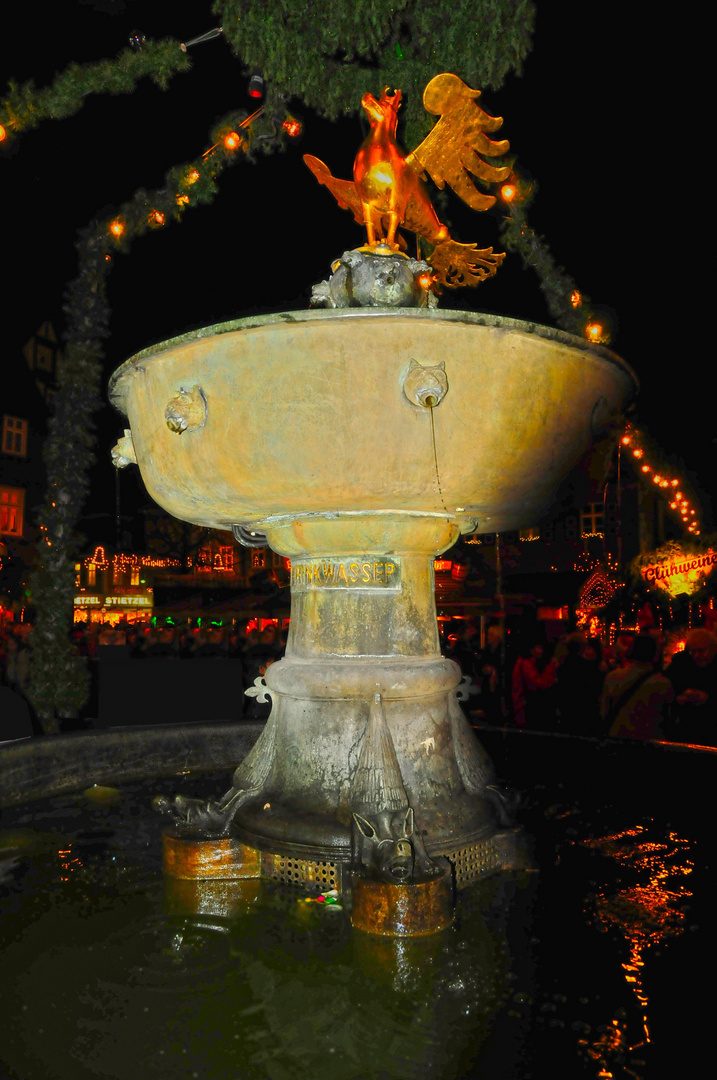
[110,309,635,532]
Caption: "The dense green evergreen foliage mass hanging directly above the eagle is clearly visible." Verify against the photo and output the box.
[213,0,535,146]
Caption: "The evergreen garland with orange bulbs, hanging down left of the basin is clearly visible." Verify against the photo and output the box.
[27,108,298,733]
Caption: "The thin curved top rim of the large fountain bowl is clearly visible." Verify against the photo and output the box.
[108,308,639,416]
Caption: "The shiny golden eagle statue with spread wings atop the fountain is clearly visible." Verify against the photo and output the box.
[303,73,510,288]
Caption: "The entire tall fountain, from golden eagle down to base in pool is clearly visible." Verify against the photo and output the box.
[105,75,635,935]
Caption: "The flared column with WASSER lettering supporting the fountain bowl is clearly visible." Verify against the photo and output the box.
[233,511,507,863]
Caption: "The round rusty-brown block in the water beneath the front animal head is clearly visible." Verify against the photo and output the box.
[351,860,454,937]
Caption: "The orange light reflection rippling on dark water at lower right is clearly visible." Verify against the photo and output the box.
[580,825,694,1080]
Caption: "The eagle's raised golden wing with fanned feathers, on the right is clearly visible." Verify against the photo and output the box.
[408,75,511,210]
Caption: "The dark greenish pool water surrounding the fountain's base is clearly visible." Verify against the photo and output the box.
[0,737,714,1080]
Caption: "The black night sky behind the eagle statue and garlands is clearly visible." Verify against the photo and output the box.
[0,0,716,540]
